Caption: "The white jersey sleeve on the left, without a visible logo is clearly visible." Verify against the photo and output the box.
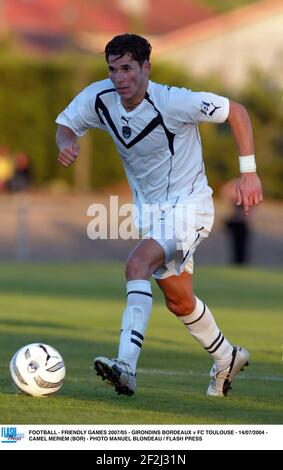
[56,83,103,137]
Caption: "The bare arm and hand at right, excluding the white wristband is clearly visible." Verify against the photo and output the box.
[227,101,263,215]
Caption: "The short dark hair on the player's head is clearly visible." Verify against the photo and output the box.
[104,33,151,66]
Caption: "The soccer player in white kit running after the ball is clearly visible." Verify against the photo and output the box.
[56,34,263,397]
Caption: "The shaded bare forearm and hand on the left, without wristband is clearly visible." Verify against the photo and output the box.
[56,125,80,167]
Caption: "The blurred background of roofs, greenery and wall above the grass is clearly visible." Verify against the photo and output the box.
[0,0,283,266]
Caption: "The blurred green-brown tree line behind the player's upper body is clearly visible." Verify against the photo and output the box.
[0,55,283,198]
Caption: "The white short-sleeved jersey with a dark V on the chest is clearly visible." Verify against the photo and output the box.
[56,79,229,206]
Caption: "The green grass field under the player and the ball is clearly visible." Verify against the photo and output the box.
[0,264,283,424]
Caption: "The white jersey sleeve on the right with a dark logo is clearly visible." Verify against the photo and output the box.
[168,87,229,123]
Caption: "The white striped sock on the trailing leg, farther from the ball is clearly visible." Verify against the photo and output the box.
[179,297,233,370]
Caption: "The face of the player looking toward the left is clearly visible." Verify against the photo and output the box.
[108,54,150,103]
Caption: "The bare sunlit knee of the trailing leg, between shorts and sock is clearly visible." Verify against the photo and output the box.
[155,272,195,315]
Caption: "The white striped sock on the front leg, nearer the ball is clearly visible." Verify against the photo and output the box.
[118,280,152,373]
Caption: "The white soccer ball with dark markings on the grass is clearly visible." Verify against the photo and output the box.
[10,343,66,397]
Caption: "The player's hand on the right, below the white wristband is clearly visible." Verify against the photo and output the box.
[236,173,263,215]
